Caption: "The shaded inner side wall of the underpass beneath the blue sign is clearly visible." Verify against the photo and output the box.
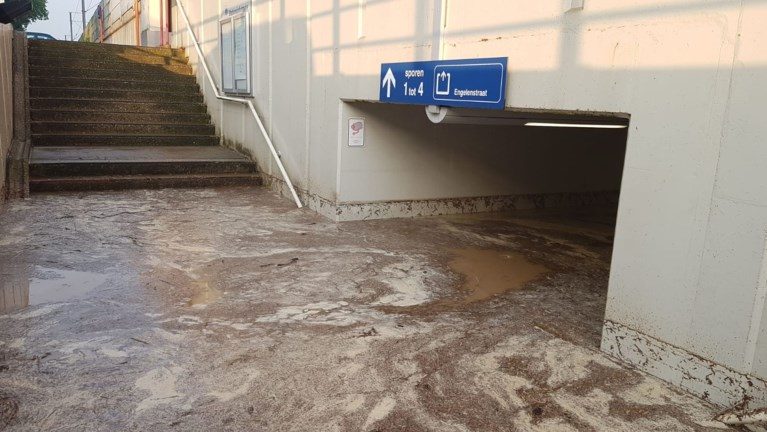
[339,102,627,202]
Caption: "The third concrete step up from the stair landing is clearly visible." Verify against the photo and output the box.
[30,109,210,125]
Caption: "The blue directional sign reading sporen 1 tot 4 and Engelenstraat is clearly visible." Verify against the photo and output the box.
[379,57,508,109]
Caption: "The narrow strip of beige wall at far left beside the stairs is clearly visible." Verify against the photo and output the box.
[0,24,13,202]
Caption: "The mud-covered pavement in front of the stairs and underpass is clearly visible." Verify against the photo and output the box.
[0,188,744,431]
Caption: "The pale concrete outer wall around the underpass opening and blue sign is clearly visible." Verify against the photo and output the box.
[174,0,767,404]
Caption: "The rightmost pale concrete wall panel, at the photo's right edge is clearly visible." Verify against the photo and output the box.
[690,1,767,378]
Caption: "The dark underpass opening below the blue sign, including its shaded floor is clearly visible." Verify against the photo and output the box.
[338,101,629,346]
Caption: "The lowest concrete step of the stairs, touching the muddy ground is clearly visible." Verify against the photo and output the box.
[29,173,262,192]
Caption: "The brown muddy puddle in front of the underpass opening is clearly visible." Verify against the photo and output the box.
[449,248,550,303]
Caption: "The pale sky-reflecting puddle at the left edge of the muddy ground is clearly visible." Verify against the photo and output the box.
[0,266,107,314]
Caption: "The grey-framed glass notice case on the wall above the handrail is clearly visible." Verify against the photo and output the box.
[219,7,251,94]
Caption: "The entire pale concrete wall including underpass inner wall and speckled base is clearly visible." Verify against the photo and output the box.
[97,0,767,405]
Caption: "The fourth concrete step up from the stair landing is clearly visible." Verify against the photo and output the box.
[30,98,207,114]
